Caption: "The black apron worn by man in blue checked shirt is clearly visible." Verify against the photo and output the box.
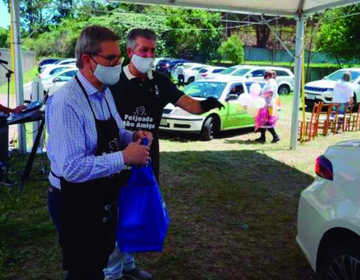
[60,76,130,271]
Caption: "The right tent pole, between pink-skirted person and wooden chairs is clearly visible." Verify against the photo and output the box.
[290,14,305,150]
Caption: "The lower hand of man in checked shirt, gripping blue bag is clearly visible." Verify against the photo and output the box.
[122,139,150,165]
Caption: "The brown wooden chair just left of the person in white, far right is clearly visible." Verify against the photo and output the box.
[315,103,339,136]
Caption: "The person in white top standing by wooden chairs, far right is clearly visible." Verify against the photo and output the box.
[333,71,354,133]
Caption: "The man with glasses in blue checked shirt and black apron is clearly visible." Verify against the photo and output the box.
[45,26,152,280]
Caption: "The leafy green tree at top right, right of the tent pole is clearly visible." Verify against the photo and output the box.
[316,4,360,61]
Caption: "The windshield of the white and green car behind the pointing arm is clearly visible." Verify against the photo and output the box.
[184,81,226,99]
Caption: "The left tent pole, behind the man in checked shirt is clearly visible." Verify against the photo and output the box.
[11,0,26,154]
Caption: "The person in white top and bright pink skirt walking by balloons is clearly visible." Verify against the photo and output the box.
[255,70,280,143]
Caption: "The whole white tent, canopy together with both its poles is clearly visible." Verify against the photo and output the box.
[11,0,359,152]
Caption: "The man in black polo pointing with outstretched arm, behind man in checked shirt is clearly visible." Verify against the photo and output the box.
[104,28,224,280]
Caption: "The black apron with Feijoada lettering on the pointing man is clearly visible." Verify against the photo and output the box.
[113,73,162,180]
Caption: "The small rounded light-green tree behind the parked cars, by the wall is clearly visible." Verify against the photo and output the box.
[218,34,244,64]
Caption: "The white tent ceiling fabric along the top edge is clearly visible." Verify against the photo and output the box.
[113,0,359,15]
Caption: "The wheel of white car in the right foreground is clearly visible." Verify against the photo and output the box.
[321,243,360,280]
